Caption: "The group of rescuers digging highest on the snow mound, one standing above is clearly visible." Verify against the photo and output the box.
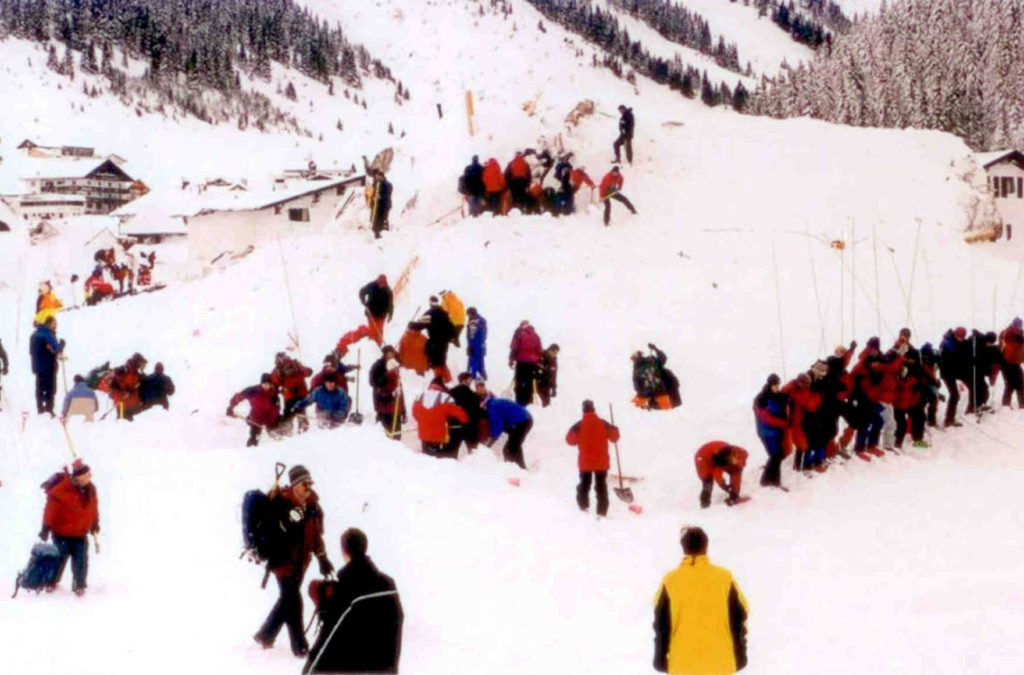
[459,106,637,225]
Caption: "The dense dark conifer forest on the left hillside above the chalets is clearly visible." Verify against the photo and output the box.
[0,0,390,91]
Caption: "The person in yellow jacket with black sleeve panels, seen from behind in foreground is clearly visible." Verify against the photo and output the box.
[654,528,748,675]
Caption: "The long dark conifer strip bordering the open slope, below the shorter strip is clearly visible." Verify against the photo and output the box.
[526,0,749,110]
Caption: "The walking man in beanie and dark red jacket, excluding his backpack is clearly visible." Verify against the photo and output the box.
[253,464,334,658]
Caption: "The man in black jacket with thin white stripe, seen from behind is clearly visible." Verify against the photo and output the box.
[302,528,404,674]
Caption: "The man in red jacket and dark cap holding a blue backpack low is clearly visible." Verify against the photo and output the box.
[39,459,99,596]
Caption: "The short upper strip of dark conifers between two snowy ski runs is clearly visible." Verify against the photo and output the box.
[608,0,742,73]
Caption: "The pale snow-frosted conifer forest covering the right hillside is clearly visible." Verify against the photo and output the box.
[751,0,1024,151]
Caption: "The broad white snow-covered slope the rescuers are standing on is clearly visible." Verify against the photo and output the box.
[0,0,1024,675]
